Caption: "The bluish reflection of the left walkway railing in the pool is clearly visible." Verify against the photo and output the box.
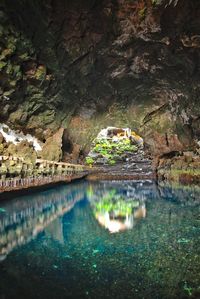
[0,184,84,261]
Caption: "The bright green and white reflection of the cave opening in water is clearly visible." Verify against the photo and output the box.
[87,182,152,233]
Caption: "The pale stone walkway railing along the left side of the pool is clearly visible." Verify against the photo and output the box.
[0,156,91,192]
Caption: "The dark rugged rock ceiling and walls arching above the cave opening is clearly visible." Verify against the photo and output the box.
[0,0,200,161]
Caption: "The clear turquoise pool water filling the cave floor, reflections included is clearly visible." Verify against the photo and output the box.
[0,181,200,299]
